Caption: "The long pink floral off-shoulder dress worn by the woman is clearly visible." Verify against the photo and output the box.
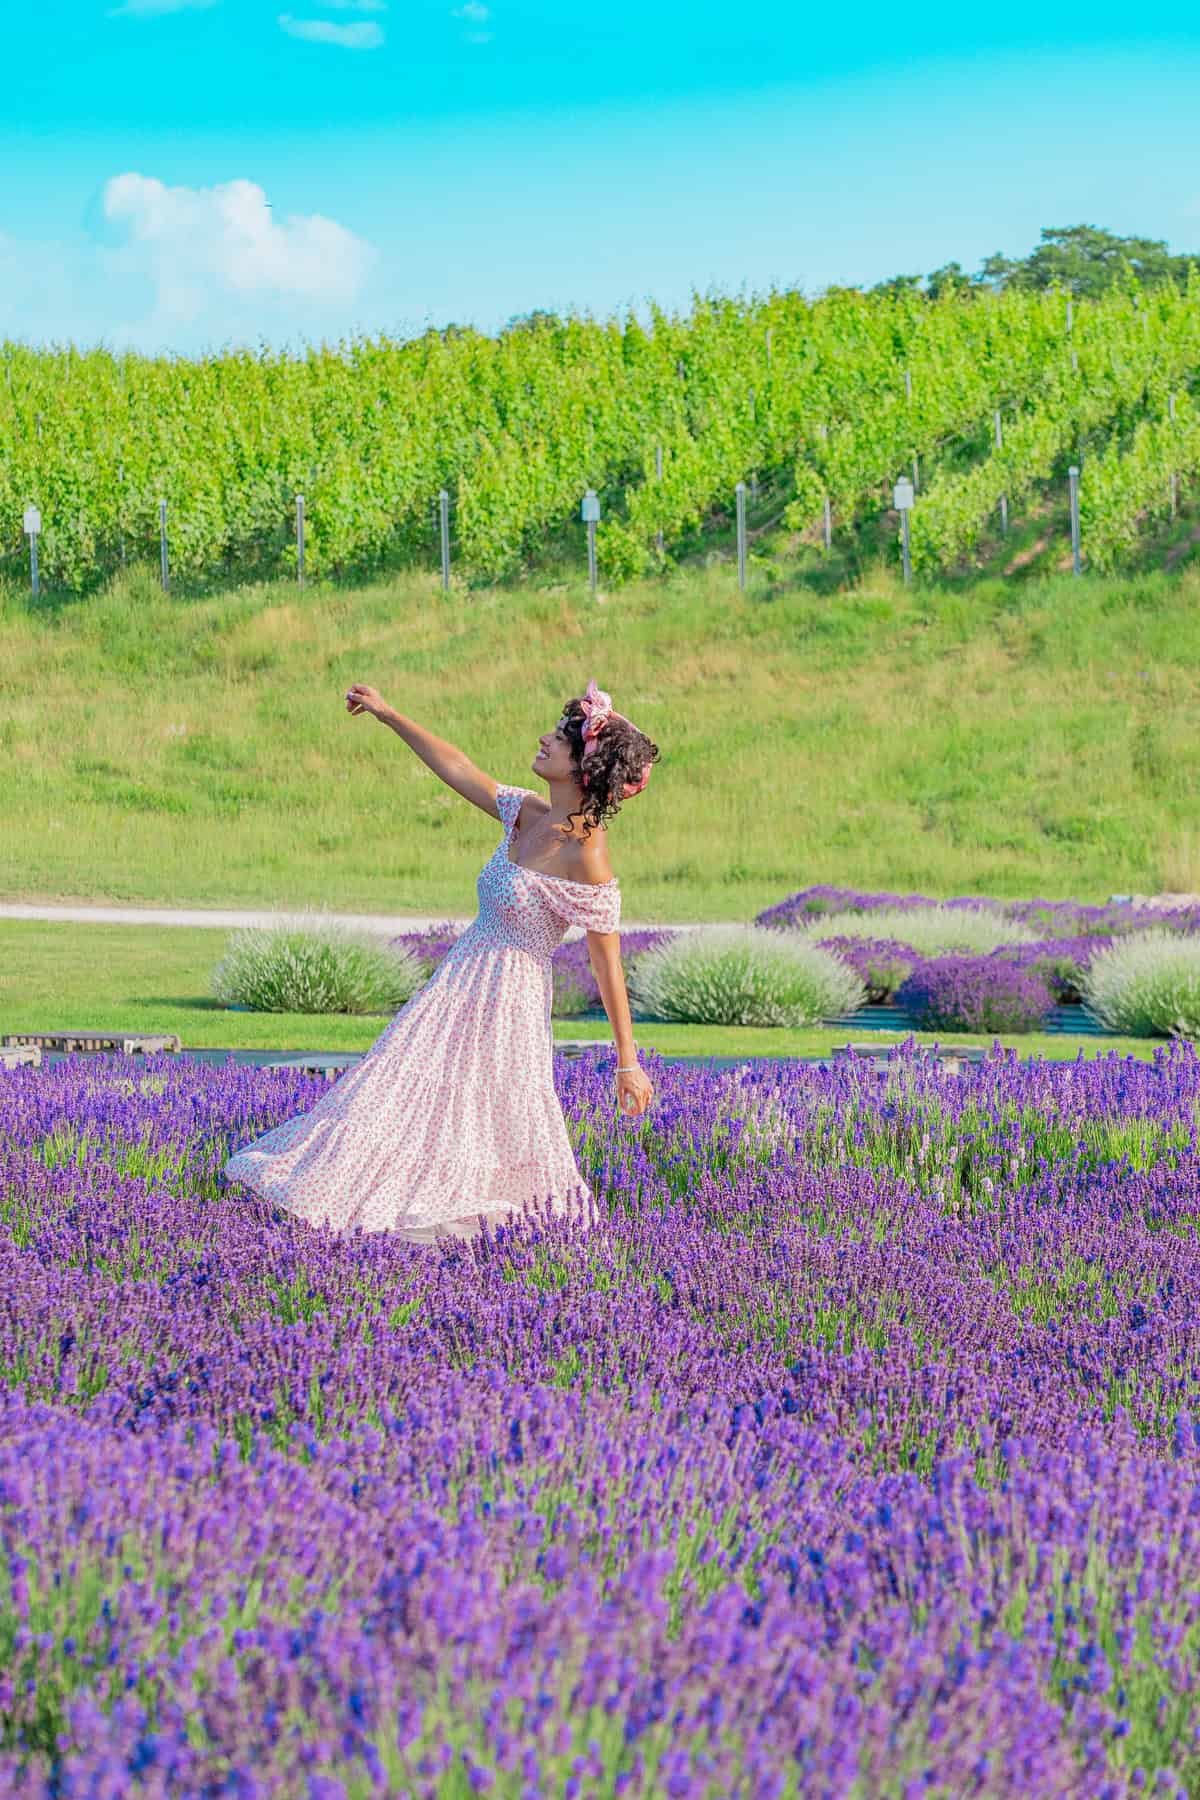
[221,785,621,1244]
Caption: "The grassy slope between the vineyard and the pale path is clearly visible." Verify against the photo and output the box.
[0,540,1200,922]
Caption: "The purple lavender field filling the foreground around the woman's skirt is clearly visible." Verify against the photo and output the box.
[0,1042,1200,1800]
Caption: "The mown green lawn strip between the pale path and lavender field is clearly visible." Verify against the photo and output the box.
[0,920,1180,1057]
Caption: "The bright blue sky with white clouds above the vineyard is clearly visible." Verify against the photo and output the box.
[0,0,1200,353]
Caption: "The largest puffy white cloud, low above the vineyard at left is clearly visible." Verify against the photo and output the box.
[103,173,374,326]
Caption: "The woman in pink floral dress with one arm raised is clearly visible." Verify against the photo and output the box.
[223,680,658,1244]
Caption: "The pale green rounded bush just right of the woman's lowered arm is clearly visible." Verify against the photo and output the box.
[630,925,865,1026]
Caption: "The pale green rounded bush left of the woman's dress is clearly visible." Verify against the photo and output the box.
[212,922,426,1013]
